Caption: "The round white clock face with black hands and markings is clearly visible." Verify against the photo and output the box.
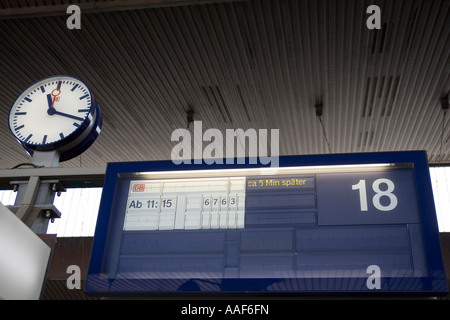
[9,76,95,150]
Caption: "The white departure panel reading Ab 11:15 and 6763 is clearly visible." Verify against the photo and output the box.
[123,177,245,231]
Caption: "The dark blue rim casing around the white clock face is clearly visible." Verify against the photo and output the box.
[8,74,97,153]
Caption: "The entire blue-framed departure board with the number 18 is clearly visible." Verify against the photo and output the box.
[86,151,447,295]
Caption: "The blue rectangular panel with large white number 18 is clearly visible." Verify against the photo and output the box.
[317,168,419,225]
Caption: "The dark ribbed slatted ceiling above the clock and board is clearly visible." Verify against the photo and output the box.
[0,0,450,168]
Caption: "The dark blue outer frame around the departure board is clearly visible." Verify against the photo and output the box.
[85,151,448,296]
